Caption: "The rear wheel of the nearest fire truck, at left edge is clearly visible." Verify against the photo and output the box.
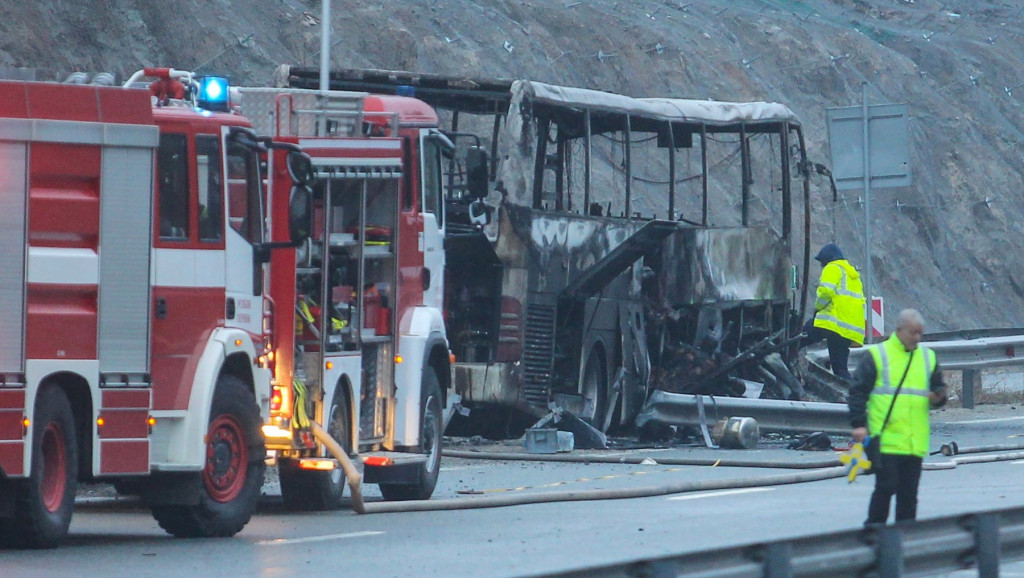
[2,385,78,548]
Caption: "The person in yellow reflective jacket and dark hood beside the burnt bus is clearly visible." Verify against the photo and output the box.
[800,243,864,379]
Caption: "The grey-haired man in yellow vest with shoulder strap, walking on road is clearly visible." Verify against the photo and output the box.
[849,309,946,526]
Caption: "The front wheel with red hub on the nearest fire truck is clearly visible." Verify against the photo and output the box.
[153,375,266,538]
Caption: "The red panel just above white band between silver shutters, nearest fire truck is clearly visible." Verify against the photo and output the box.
[29,142,101,249]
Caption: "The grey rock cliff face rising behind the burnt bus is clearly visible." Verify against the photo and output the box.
[0,0,1024,330]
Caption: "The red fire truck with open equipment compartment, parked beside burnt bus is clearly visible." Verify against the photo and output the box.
[233,83,468,509]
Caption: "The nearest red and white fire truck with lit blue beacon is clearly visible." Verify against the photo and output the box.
[0,69,315,547]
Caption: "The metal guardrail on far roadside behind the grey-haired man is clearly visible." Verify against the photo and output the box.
[807,329,1024,409]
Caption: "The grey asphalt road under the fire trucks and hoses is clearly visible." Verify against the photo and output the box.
[0,407,1024,578]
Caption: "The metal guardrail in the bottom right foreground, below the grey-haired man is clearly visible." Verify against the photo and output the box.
[544,507,1024,578]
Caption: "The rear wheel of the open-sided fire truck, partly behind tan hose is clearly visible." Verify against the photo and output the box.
[278,387,352,511]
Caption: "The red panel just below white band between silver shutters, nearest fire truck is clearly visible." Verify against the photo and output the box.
[25,283,97,360]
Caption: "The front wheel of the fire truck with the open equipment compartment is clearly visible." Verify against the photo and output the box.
[380,371,444,501]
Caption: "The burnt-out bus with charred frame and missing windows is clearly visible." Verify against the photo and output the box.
[288,68,809,429]
